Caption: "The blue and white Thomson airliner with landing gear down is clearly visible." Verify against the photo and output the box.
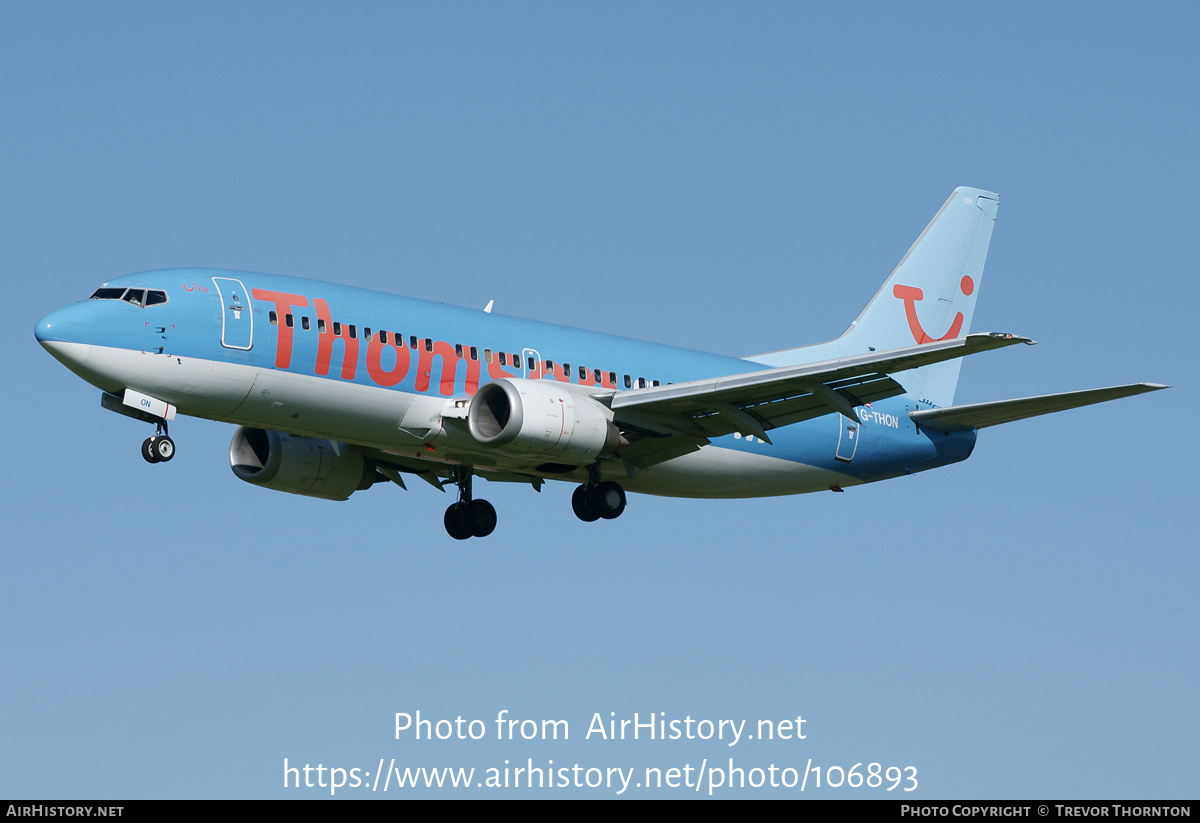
[35,187,1169,540]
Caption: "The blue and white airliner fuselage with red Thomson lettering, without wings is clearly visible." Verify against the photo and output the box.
[37,269,976,497]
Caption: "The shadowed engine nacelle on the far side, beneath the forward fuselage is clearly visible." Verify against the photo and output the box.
[229,426,376,500]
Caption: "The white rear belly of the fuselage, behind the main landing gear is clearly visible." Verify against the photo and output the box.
[620,445,862,498]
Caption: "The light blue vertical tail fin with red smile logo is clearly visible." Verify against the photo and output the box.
[748,187,1000,406]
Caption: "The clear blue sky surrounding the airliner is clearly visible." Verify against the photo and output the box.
[0,2,1200,799]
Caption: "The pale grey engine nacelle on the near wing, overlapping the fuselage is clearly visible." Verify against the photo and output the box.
[467,378,623,465]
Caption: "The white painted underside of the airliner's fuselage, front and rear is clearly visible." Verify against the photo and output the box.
[43,342,859,498]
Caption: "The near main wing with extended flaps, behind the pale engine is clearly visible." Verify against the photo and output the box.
[612,332,1034,468]
